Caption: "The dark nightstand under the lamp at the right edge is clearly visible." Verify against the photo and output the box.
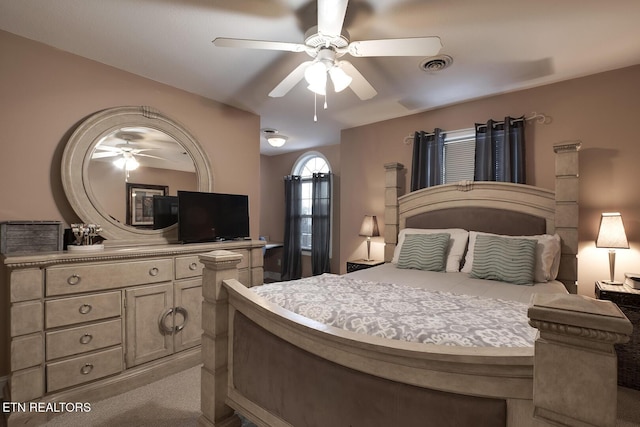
[596,281,640,390]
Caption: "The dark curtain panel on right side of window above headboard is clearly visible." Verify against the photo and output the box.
[474,117,526,184]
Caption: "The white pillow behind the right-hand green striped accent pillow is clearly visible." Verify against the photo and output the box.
[460,231,560,283]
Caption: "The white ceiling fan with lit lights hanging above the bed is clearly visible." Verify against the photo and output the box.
[213,0,442,100]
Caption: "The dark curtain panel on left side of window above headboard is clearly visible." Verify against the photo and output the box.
[411,128,445,191]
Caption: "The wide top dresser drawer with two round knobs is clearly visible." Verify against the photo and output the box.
[45,258,173,296]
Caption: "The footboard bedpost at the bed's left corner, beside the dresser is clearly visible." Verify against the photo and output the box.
[198,250,242,427]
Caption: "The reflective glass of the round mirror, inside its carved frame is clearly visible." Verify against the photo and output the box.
[89,127,198,229]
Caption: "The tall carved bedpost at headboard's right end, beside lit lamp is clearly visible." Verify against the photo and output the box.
[553,141,582,294]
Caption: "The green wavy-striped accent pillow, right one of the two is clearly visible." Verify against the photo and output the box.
[470,234,537,285]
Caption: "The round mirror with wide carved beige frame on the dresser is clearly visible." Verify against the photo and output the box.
[62,107,213,246]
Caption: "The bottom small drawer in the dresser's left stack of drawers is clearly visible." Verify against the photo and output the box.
[47,347,123,392]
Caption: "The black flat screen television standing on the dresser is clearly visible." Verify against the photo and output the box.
[178,191,249,243]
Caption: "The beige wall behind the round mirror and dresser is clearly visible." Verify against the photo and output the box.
[0,31,261,377]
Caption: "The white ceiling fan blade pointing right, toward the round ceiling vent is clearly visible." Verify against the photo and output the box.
[348,37,442,56]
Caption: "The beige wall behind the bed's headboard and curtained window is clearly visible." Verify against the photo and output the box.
[340,66,640,295]
